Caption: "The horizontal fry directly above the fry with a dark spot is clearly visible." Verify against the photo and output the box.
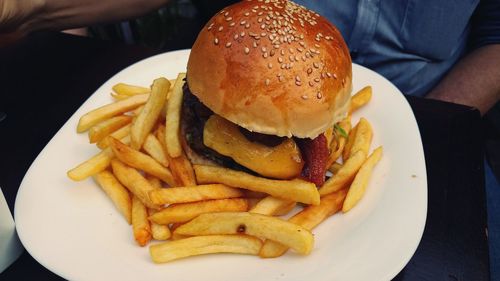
[149,198,248,224]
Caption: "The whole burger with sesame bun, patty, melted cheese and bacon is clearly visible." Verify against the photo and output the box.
[181,0,352,186]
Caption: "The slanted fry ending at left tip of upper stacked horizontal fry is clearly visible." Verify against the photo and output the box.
[111,159,160,209]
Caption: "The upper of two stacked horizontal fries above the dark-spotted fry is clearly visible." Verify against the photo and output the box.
[149,184,243,205]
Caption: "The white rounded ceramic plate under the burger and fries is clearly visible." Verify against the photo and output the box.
[15,50,427,281]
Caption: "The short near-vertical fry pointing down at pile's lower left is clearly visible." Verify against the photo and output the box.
[132,196,151,247]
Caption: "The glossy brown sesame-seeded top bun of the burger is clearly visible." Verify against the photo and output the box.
[187,0,352,138]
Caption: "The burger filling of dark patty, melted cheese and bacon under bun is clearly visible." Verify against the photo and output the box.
[181,84,329,186]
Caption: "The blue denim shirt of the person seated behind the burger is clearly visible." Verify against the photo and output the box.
[296,0,500,96]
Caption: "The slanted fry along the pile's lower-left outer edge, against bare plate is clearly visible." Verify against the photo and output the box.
[94,170,132,224]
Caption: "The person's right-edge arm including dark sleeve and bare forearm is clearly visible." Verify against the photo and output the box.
[427,0,500,114]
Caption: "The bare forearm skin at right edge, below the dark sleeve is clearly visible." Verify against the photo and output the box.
[426,44,500,114]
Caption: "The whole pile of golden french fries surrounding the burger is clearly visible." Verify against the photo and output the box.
[68,73,382,263]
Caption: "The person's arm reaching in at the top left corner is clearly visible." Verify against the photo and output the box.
[0,0,168,34]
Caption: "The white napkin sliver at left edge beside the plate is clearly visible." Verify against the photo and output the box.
[0,188,23,273]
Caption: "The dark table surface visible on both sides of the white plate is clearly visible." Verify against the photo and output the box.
[0,30,489,280]
